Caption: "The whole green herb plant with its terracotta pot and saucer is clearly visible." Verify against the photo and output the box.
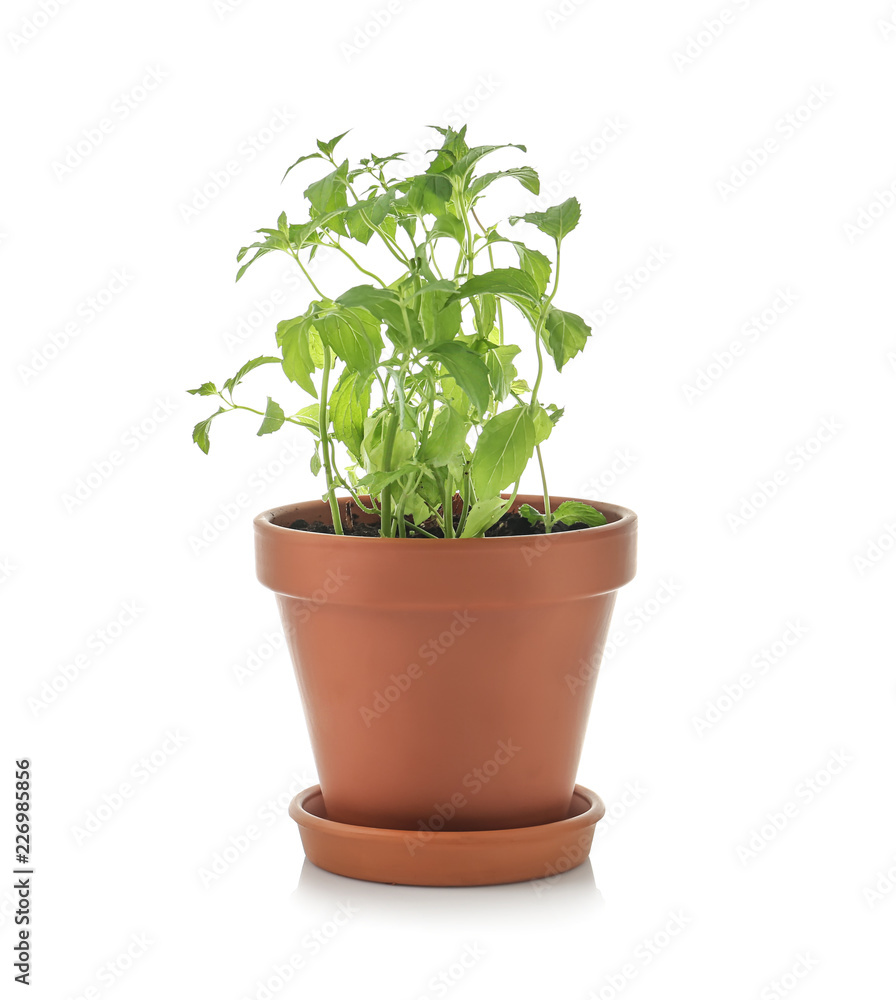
[190,128,636,884]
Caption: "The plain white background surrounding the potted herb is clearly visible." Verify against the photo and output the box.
[0,0,896,1000]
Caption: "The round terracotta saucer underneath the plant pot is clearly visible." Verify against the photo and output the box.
[289,785,606,886]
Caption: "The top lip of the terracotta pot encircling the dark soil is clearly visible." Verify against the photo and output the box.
[254,493,638,551]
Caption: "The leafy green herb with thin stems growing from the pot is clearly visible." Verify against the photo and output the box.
[189,127,605,538]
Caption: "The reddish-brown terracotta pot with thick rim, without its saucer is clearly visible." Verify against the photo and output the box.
[255,496,637,831]
